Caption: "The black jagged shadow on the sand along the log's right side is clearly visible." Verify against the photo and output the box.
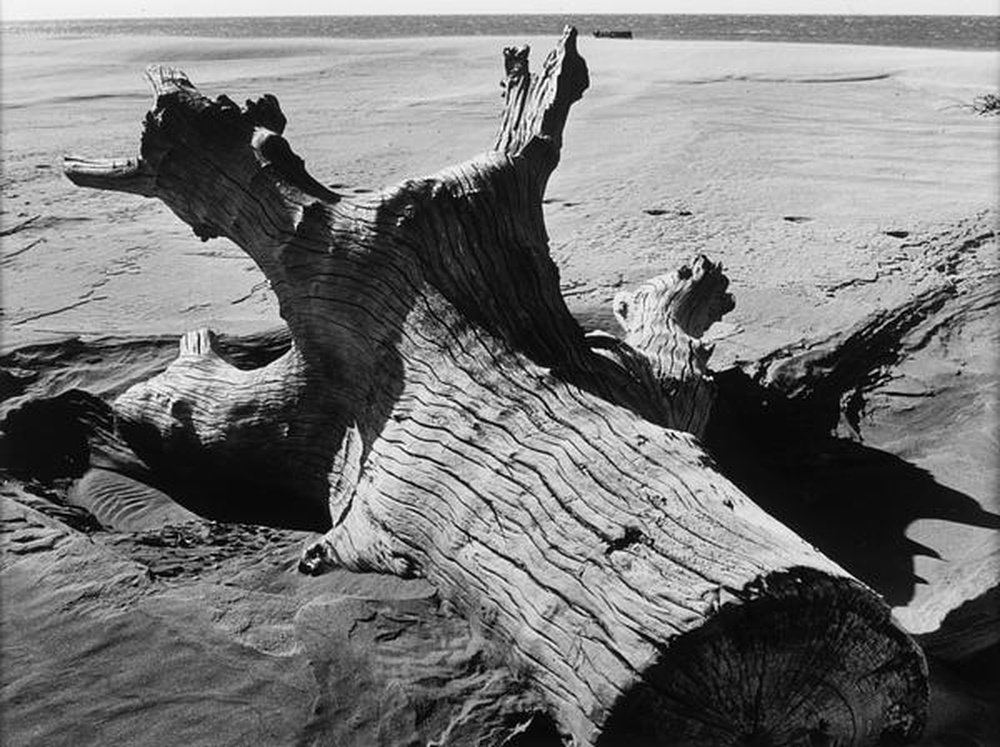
[705,369,1000,606]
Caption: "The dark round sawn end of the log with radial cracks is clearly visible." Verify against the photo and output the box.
[597,569,928,747]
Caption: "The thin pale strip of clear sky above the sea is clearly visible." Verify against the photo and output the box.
[0,0,1000,21]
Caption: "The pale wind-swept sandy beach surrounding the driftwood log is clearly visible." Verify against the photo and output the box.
[0,30,1000,747]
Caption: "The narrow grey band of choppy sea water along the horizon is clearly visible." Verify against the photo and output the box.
[3,15,1000,49]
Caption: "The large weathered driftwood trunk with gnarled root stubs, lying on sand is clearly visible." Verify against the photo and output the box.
[66,29,927,745]
